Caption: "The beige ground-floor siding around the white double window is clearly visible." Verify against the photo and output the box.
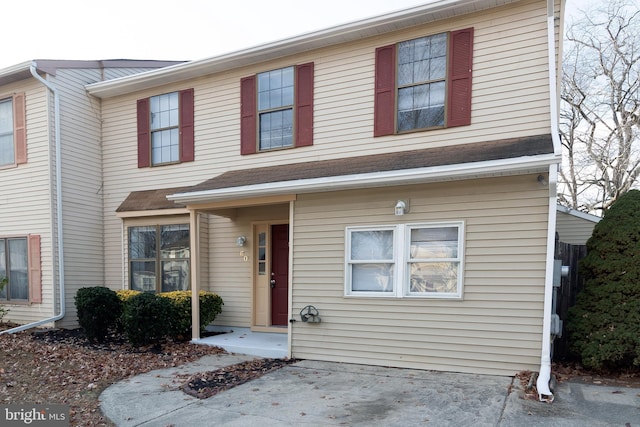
[292,175,548,375]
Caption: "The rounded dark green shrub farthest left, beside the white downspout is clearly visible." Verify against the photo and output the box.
[75,286,122,341]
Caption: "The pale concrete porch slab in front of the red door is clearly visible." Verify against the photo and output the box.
[192,326,289,359]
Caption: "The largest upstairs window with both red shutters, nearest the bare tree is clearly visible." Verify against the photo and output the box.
[374,28,473,136]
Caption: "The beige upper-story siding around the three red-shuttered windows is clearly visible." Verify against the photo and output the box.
[102,0,550,290]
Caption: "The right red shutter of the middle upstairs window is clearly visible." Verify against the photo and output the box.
[295,62,313,147]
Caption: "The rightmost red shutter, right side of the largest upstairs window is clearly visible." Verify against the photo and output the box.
[447,28,473,127]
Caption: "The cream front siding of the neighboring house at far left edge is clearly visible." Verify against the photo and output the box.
[0,79,57,323]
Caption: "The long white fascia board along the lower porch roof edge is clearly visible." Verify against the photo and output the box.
[167,154,560,204]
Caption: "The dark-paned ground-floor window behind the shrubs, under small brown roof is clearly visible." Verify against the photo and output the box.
[129,224,190,292]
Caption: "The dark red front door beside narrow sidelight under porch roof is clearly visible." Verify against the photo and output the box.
[270,224,289,326]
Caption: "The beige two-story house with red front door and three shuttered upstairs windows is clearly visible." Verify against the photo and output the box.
[82,0,563,398]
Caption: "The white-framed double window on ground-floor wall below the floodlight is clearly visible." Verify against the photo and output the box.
[345,222,464,298]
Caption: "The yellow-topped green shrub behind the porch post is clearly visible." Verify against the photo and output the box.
[160,291,224,337]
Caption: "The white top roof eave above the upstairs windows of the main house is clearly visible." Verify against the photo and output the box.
[87,0,519,98]
